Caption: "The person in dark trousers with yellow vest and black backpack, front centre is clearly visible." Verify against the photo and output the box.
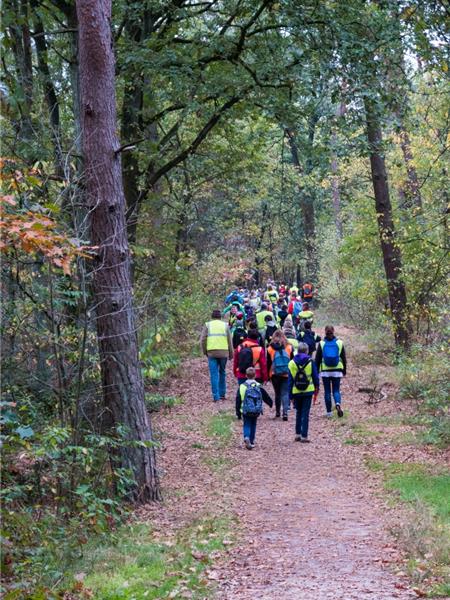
[288,342,320,443]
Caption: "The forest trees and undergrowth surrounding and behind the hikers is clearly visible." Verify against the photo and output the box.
[0,0,450,592]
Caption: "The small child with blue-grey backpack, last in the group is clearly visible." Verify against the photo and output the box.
[236,367,273,450]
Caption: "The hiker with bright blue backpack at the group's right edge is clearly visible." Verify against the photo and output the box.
[316,325,347,417]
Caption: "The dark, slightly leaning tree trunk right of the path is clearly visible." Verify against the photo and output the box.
[364,97,409,347]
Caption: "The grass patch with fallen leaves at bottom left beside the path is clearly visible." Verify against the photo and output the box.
[78,517,231,600]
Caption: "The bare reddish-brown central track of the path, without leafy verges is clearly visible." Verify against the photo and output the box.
[214,346,417,600]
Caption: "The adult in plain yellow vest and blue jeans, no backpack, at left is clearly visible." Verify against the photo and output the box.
[200,310,233,402]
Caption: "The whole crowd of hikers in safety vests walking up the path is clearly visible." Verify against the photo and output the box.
[200,282,347,450]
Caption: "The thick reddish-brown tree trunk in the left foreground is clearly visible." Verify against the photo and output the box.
[77,0,159,502]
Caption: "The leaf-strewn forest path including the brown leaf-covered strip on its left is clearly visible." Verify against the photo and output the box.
[151,328,417,600]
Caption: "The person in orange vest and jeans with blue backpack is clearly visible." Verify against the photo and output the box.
[267,329,294,421]
